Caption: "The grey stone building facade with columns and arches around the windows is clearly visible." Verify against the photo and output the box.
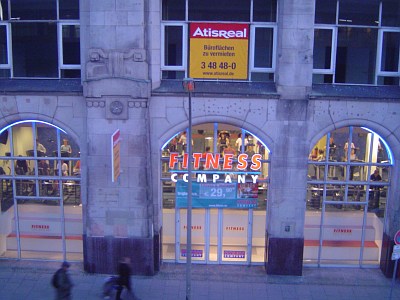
[0,0,400,276]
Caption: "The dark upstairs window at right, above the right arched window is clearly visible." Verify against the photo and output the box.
[313,0,400,86]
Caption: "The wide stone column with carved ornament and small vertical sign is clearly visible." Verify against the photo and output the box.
[81,0,155,275]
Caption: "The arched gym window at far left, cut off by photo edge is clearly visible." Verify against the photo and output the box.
[0,120,82,260]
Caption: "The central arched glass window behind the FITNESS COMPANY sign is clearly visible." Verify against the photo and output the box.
[161,123,269,264]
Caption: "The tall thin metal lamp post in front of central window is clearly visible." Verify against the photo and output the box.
[182,78,194,300]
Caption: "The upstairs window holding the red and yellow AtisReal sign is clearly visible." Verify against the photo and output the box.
[161,0,277,81]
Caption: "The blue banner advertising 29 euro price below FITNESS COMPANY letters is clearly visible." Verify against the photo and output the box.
[176,181,258,208]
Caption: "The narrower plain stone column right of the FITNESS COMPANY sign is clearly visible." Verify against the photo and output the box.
[266,0,315,275]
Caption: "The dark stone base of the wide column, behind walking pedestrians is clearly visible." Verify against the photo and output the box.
[83,235,155,276]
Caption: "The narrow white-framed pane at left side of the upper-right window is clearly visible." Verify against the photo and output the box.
[314,29,332,69]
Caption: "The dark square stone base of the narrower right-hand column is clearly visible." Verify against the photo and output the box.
[267,238,304,276]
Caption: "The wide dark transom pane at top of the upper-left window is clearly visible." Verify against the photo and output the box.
[10,0,57,20]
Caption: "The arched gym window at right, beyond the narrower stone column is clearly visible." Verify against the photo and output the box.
[304,126,392,265]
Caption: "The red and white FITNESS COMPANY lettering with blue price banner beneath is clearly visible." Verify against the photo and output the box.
[169,153,262,208]
